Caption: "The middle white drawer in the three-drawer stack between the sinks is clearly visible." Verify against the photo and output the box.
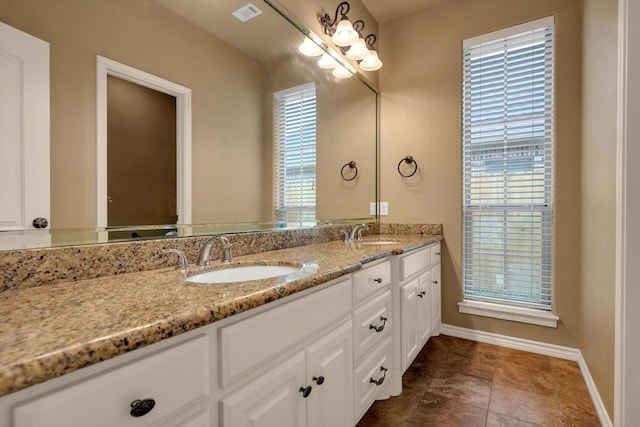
[353,291,392,360]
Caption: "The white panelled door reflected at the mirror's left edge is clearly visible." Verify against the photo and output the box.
[0,23,50,231]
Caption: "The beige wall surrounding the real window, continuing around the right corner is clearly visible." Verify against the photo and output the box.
[380,0,616,413]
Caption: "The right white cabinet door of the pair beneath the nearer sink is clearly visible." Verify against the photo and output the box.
[307,322,353,427]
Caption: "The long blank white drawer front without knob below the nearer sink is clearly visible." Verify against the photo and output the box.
[220,279,351,387]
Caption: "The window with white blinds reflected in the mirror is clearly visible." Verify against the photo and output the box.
[273,82,316,225]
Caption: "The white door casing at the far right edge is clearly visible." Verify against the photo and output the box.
[614,0,640,427]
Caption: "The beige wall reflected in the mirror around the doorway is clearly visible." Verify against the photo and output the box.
[0,0,263,228]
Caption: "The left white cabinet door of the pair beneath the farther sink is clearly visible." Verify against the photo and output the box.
[400,278,420,372]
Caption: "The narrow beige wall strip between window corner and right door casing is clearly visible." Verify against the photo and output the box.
[580,0,617,415]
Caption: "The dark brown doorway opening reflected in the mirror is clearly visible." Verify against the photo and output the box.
[107,76,178,227]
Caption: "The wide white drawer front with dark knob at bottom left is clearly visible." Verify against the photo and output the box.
[13,336,210,427]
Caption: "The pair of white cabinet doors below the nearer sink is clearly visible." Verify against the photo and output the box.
[221,322,353,427]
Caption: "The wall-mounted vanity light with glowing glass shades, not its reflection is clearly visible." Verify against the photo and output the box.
[320,1,382,71]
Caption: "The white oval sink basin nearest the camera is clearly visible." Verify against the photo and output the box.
[185,265,301,283]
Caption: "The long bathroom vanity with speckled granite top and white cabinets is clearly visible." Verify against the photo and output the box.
[0,235,441,427]
